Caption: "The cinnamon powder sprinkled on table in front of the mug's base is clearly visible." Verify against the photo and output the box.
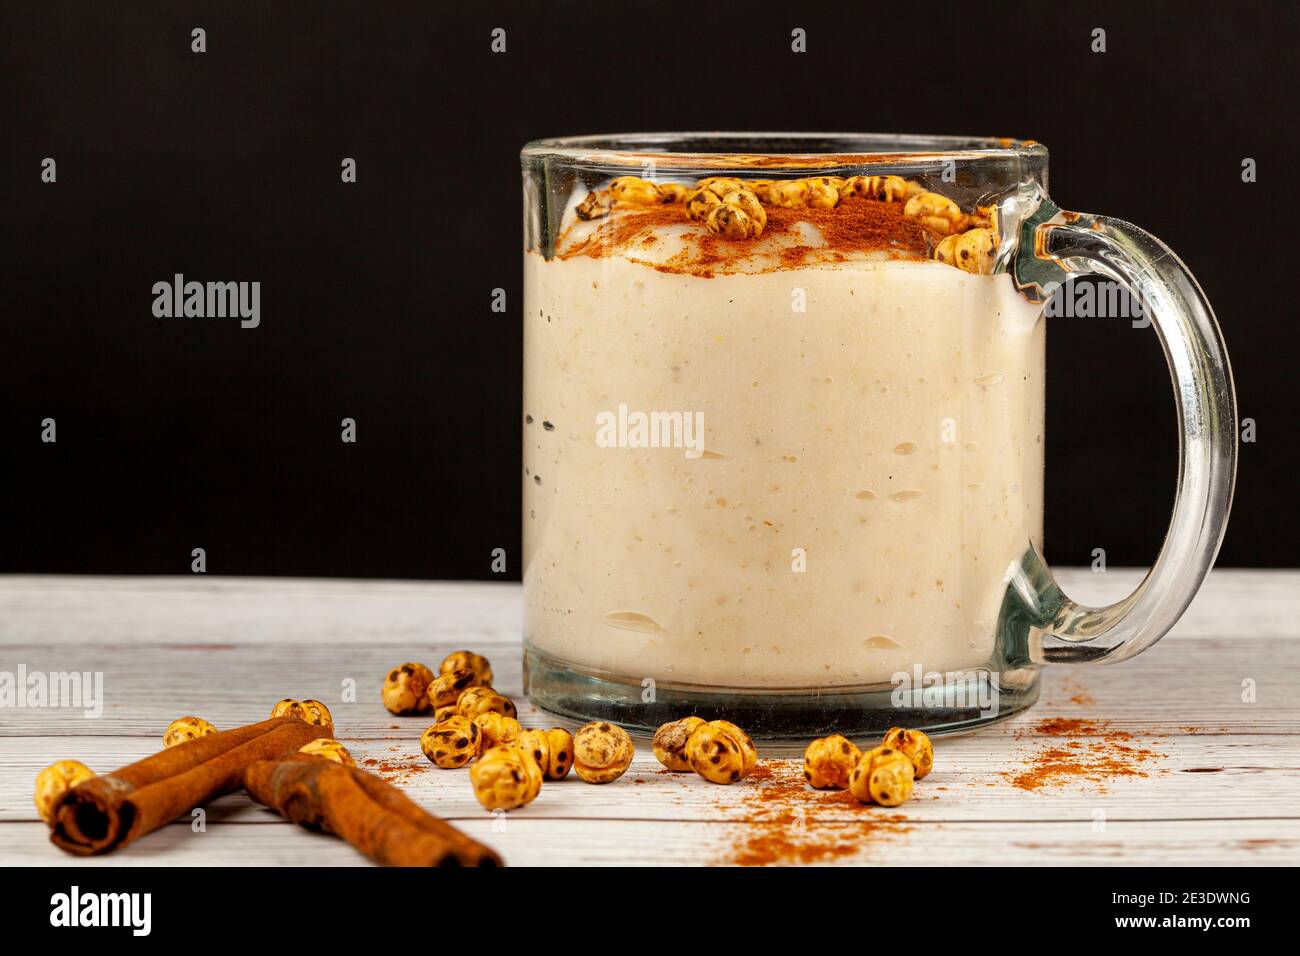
[719,760,911,866]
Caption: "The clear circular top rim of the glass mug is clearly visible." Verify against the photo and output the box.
[520,131,1048,169]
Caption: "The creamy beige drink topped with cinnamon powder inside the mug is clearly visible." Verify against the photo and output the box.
[524,174,1044,688]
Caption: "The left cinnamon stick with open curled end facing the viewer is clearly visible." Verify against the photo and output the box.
[49,717,332,856]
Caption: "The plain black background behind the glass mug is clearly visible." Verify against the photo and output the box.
[0,0,1300,578]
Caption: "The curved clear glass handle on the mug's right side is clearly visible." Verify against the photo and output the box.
[1010,196,1238,663]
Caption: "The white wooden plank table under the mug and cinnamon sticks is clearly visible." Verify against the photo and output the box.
[0,570,1300,866]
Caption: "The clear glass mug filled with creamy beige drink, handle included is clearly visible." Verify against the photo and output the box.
[521,133,1236,737]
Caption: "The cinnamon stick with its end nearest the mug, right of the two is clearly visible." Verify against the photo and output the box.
[244,753,501,866]
